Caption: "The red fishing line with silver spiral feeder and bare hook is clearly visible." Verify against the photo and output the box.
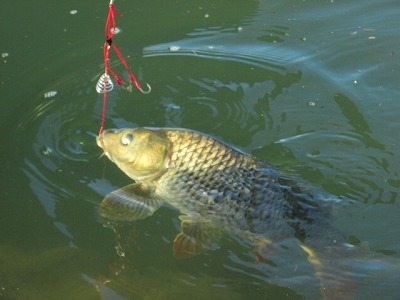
[96,0,151,135]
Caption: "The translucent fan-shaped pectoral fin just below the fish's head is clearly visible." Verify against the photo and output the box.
[98,183,162,222]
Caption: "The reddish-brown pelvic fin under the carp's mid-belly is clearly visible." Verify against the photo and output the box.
[173,216,221,257]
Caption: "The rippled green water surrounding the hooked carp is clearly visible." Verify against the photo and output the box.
[0,0,400,299]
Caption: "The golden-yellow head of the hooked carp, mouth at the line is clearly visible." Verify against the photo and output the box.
[96,128,171,181]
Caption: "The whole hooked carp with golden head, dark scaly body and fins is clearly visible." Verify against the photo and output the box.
[96,127,353,299]
